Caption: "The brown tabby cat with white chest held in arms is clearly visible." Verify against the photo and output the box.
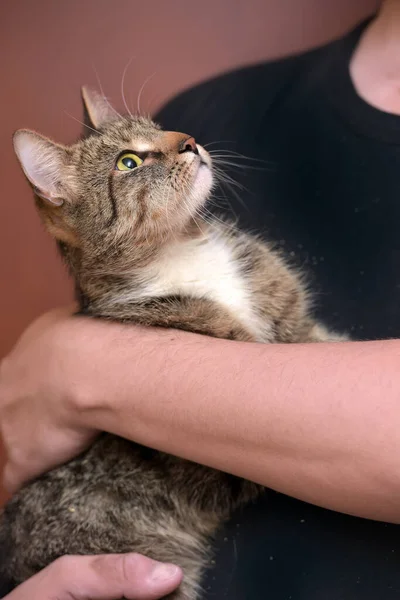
[0,88,344,600]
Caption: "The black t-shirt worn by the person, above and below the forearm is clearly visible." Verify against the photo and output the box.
[157,18,400,600]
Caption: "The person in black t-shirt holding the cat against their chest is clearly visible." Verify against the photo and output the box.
[0,0,400,600]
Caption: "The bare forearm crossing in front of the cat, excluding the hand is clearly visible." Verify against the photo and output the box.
[72,323,400,522]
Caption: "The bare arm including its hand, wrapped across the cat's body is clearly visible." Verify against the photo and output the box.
[0,308,400,522]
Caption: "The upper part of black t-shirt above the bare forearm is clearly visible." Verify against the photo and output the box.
[159,21,400,339]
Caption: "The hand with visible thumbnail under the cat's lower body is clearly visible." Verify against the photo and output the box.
[4,554,182,600]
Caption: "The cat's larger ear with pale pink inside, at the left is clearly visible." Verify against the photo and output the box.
[13,129,67,206]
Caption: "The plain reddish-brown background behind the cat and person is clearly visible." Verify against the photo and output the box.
[0,0,378,502]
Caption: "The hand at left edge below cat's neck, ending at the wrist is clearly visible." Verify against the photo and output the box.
[0,307,98,493]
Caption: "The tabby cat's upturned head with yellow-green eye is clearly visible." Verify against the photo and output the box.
[14,88,213,268]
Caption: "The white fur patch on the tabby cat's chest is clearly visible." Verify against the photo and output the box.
[130,235,266,341]
